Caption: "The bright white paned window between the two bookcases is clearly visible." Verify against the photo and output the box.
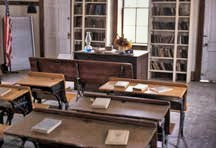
[123,0,149,44]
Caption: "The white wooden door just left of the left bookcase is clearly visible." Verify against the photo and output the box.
[44,0,71,58]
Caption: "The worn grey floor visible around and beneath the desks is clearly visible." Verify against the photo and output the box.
[3,72,216,148]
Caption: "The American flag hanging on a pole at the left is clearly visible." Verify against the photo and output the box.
[4,0,12,67]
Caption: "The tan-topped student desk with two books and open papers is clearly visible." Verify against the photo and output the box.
[99,78,188,144]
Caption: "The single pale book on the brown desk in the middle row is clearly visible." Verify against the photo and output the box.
[92,98,111,109]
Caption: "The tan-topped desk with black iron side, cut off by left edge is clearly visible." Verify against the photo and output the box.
[0,84,32,124]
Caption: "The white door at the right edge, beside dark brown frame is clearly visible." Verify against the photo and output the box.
[201,0,216,81]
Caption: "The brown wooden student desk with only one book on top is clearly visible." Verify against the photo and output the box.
[70,93,170,147]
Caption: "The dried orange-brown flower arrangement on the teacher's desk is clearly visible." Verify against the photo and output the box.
[113,35,132,51]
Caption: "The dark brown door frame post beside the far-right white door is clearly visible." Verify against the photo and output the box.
[194,0,206,81]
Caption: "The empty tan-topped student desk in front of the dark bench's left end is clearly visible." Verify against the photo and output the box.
[17,72,68,109]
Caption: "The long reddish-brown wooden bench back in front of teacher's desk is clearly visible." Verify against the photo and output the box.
[29,57,133,92]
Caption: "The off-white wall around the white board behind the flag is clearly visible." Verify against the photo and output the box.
[0,0,40,64]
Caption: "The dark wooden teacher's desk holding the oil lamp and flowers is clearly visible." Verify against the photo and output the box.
[74,50,148,80]
